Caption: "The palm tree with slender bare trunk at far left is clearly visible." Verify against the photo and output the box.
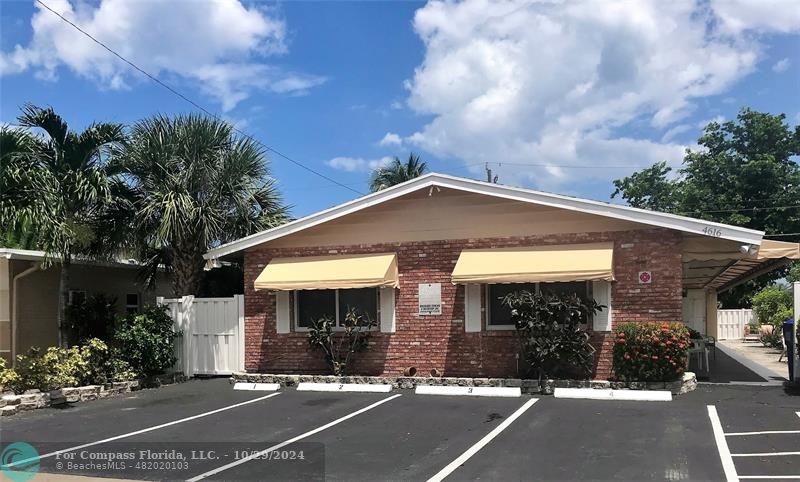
[0,104,124,345]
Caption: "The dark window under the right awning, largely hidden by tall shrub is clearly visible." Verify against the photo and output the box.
[486,281,592,330]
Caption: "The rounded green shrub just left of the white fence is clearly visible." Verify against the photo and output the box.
[114,306,177,376]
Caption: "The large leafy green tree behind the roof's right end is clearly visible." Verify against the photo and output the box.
[611,108,800,306]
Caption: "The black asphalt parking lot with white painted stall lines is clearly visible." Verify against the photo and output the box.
[0,379,800,481]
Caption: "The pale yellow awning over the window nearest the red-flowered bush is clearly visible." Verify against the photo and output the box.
[452,243,614,283]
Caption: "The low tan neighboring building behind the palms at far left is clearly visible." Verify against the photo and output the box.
[0,248,172,361]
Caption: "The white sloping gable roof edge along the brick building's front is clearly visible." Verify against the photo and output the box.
[203,173,764,259]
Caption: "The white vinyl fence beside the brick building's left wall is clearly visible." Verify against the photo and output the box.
[157,295,244,377]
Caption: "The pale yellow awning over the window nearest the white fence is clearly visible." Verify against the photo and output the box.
[255,253,399,290]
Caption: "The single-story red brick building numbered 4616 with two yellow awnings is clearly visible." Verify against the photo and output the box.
[206,174,800,378]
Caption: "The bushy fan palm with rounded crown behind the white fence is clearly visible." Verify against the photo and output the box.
[121,115,288,296]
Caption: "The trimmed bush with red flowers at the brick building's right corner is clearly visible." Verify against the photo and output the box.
[614,323,691,382]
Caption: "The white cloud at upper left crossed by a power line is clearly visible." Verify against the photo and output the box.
[0,0,325,111]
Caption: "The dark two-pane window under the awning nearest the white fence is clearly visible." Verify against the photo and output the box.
[294,288,378,331]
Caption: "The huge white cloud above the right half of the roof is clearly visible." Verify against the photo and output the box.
[405,0,800,188]
